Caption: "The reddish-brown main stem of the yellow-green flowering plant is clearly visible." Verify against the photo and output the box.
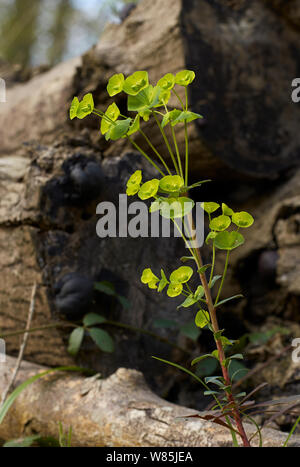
[188,213,251,447]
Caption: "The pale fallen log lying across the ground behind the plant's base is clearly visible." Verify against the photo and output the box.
[0,357,300,447]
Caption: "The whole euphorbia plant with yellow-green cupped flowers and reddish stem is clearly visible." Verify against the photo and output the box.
[70,70,253,446]
